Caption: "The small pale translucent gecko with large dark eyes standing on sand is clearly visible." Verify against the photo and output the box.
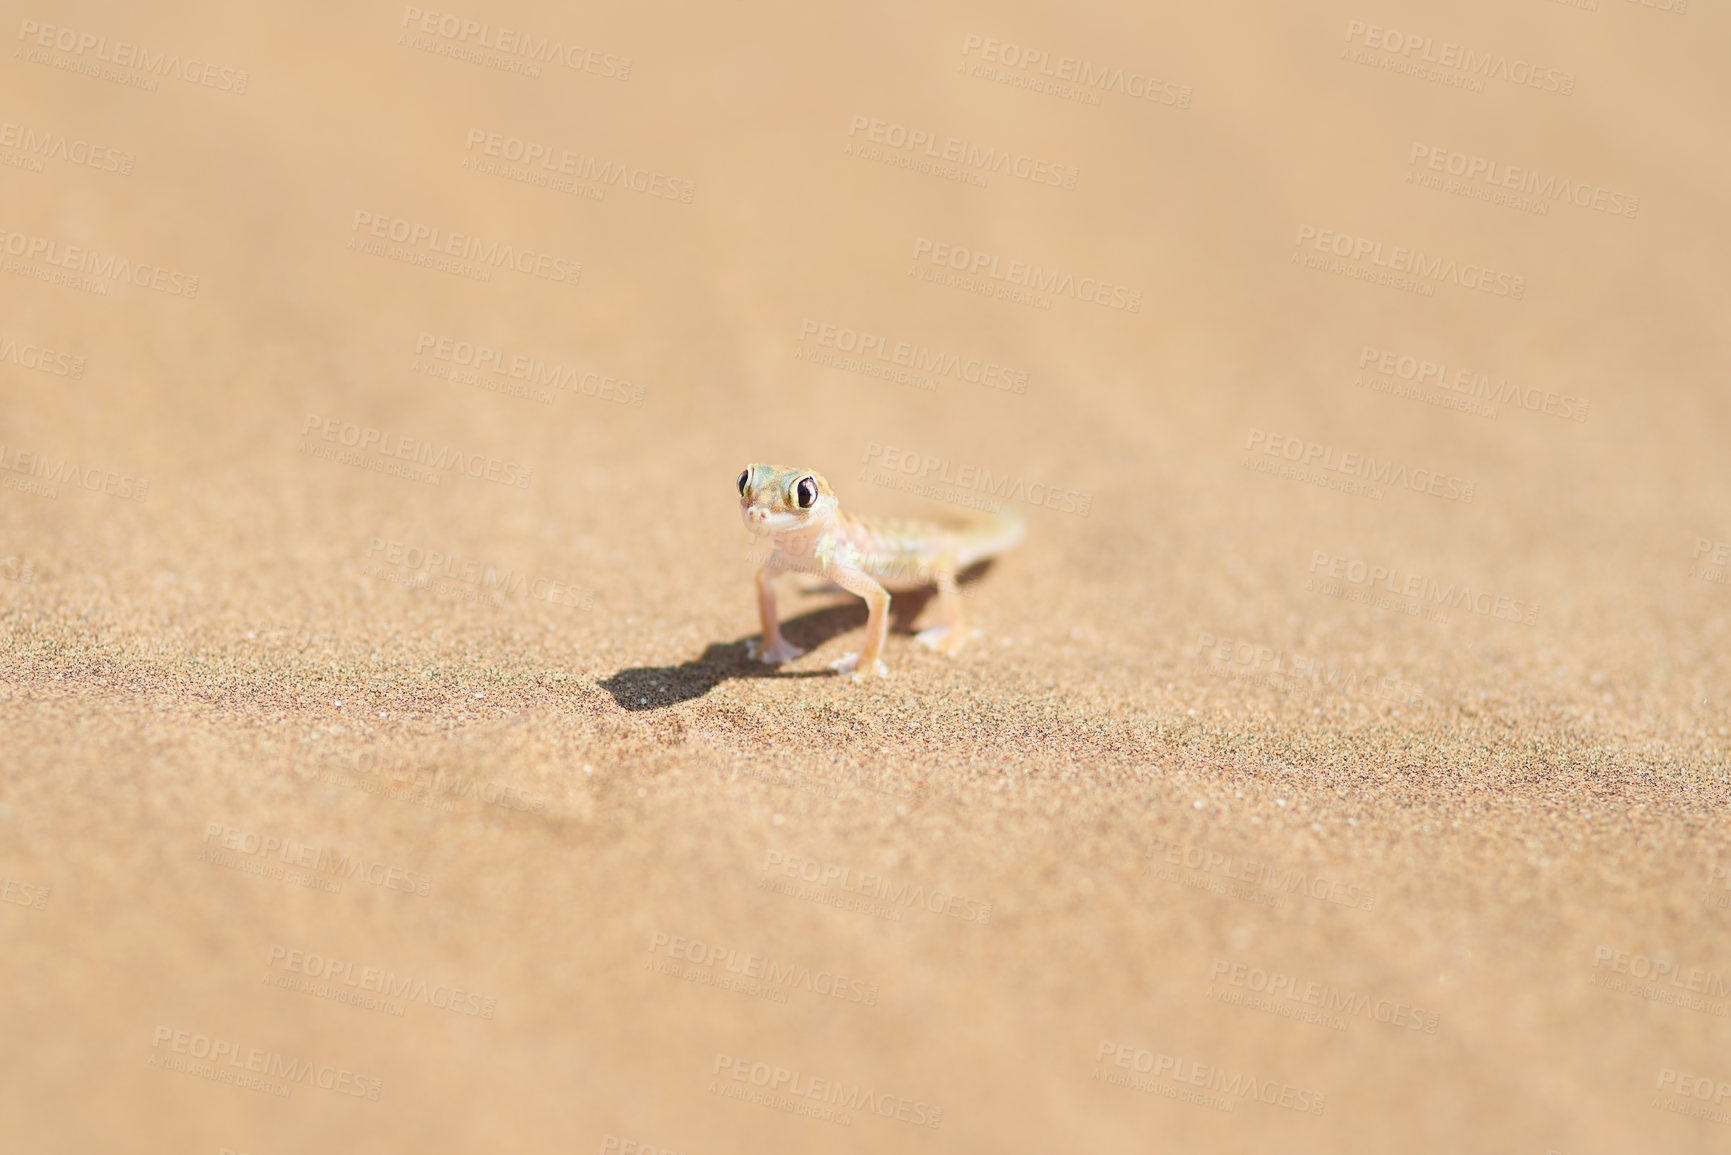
[739,464,1025,681]
